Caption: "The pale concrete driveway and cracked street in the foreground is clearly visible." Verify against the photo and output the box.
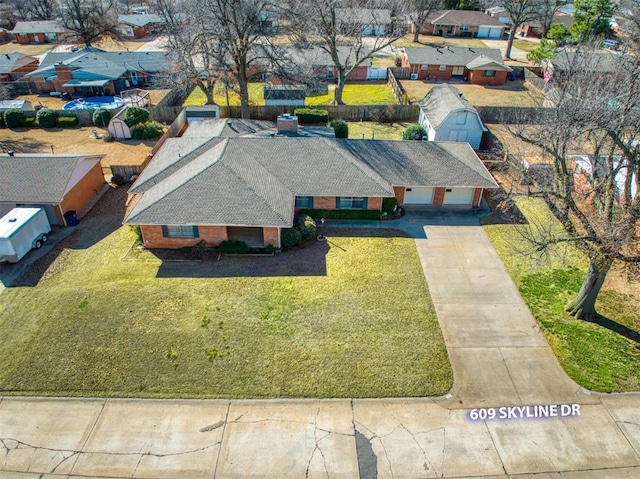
[0,212,640,479]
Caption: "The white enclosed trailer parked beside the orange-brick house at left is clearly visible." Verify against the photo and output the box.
[0,208,51,263]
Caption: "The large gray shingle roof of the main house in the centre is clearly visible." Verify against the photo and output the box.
[125,137,496,227]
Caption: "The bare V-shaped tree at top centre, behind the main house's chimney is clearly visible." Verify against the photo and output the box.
[290,0,405,105]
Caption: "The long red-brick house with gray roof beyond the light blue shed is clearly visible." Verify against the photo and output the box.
[402,46,512,85]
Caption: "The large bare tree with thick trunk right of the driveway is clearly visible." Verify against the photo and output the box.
[504,48,640,321]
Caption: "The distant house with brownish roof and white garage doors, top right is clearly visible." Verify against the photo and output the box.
[409,10,506,38]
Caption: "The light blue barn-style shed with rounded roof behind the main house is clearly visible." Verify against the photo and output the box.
[419,83,487,150]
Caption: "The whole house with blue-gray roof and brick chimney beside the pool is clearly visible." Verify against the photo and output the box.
[25,47,173,96]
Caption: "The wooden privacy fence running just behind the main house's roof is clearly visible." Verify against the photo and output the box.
[220,105,420,122]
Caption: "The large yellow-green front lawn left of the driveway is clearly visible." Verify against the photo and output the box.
[0,192,452,398]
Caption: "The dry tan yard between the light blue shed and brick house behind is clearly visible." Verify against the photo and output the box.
[400,80,544,107]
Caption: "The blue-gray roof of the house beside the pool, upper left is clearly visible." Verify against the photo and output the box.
[25,48,172,80]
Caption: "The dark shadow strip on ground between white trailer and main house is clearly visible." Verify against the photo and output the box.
[0,185,129,287]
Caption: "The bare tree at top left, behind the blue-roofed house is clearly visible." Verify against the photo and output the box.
[60,0,119,47]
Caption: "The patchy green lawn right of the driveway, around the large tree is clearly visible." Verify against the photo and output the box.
[484,198,640,392]
